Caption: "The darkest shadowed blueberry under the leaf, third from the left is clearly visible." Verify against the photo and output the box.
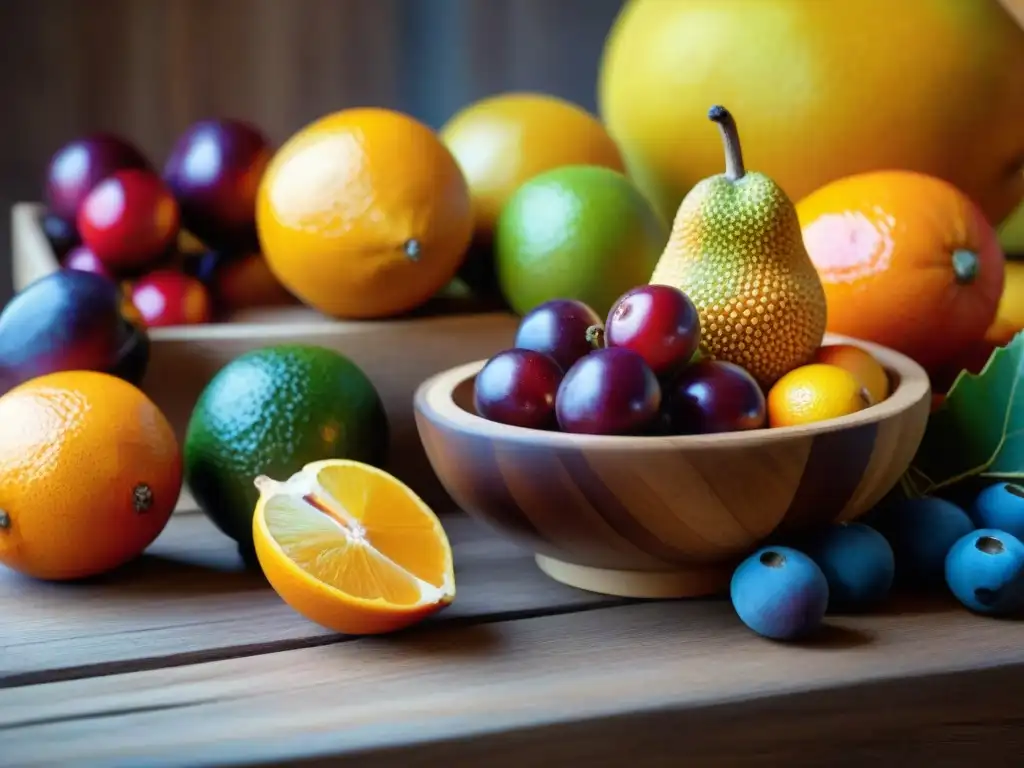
[872,497,974,588]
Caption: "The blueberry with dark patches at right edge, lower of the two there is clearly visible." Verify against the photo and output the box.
[946,528,1024,615]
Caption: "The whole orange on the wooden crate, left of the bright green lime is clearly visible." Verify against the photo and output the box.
[256,109,473,318]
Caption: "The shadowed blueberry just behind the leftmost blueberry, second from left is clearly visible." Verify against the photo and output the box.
[802,522,896,610]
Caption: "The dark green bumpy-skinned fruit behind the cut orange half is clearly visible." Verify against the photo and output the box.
[184,344,388,551]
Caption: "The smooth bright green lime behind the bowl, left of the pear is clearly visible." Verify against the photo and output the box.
[495,166,669,317]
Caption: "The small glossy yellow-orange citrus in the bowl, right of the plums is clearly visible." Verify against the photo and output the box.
[768,362,871,427]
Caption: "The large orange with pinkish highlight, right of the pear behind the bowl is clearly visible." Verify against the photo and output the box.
[797,171,1005,368]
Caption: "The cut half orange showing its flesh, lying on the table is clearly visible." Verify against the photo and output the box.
[253,459,455,635]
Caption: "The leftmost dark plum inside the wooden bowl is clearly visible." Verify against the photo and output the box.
[473,349,562,429]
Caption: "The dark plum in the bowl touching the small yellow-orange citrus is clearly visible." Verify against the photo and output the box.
[660,359,767,434]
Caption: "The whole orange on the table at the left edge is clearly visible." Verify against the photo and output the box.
[0,371,181,580]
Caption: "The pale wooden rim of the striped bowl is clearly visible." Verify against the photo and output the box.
[413,334,932,451]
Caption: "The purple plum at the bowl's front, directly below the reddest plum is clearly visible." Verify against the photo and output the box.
[555,347,662,435]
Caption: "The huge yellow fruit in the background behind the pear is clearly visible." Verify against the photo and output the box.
[599,0,1024,227]
